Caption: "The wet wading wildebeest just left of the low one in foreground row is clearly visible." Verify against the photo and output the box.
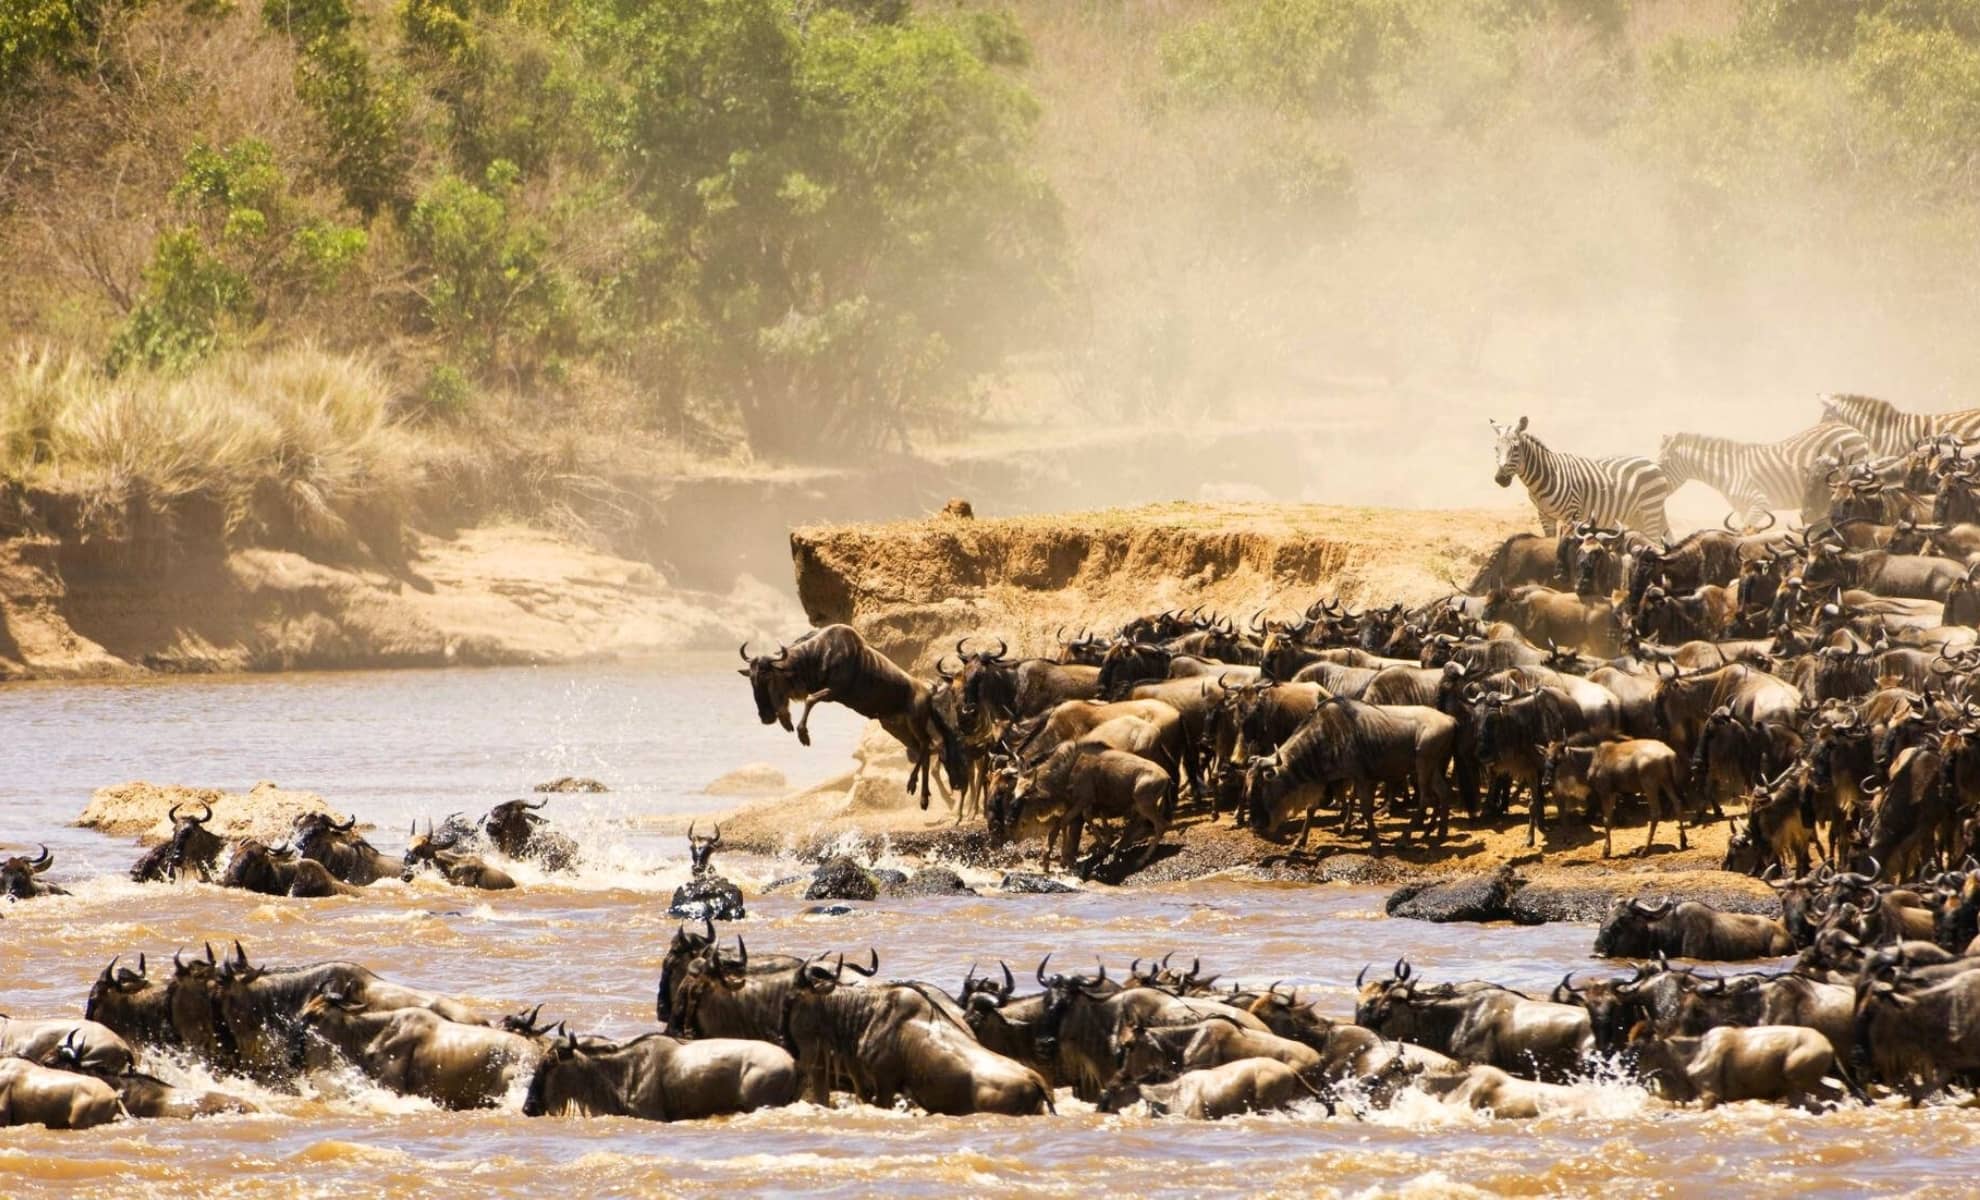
[297,984,541,1109]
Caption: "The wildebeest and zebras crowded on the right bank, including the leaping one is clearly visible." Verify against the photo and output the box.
[743,396,1980,879]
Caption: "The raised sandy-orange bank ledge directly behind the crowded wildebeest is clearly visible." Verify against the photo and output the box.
[790,503,1531,667]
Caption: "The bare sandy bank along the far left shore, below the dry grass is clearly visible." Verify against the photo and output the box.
[0,525,794,677]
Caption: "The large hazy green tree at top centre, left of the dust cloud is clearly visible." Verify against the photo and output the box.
[590,0,1059,453]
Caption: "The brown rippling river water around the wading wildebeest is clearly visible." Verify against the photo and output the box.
[0,659,1980,1200]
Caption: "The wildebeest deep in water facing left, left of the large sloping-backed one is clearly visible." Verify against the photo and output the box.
[523,1034,798,1121]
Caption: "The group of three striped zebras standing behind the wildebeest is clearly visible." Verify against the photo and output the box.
[1493,394,1980,537]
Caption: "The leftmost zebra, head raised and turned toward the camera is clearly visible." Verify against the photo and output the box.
[1491,418,1671,539]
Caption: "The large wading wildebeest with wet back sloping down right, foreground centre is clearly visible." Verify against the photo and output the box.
[786,958,1051,1117]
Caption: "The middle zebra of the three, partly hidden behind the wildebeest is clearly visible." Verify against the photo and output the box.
[1657,422,1871,521]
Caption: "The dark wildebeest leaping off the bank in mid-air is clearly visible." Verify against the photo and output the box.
[739,626,968,808]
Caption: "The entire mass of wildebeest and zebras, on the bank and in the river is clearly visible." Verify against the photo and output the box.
[19,398,1980,1127]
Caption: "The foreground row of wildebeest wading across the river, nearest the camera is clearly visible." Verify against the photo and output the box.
[15,910,1980,1129]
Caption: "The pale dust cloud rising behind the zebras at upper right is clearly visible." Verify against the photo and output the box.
[970,0,1980,525]
